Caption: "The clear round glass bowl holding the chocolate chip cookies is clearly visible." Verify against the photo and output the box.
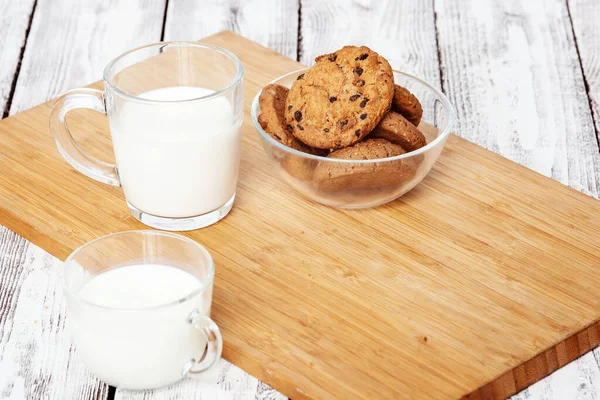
[252,69,454,208]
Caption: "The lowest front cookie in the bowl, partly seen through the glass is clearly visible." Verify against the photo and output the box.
[313,139,416,191]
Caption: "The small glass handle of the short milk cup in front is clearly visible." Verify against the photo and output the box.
[181,308,223,376]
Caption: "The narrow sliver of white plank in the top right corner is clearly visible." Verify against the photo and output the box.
[568,0,600,148]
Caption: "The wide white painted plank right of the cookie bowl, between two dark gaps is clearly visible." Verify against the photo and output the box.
[435,0,600,198]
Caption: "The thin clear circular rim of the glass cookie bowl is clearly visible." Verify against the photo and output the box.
[251,67,455,164]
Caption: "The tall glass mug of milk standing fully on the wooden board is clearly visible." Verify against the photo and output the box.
[50,42,244,231]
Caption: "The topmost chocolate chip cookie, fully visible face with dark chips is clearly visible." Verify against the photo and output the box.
[285,46,394,149]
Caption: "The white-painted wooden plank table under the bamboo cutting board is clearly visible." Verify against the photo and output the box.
[0,0,600,399]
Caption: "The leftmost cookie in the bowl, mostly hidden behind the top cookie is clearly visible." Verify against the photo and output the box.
[258,85,325,155]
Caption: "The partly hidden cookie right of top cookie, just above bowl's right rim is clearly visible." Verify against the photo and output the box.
[369,111,427,151]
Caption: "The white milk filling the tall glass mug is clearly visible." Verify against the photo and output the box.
[110,86,241,218]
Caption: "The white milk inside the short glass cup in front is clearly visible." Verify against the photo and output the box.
[69,265,212,389]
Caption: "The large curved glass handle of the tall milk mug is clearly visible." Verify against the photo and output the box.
[50,89,121,186]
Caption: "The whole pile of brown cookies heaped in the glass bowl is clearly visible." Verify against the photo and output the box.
[258,46,427,191]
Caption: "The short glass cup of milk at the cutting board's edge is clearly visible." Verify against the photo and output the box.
[62,231,223,389]
